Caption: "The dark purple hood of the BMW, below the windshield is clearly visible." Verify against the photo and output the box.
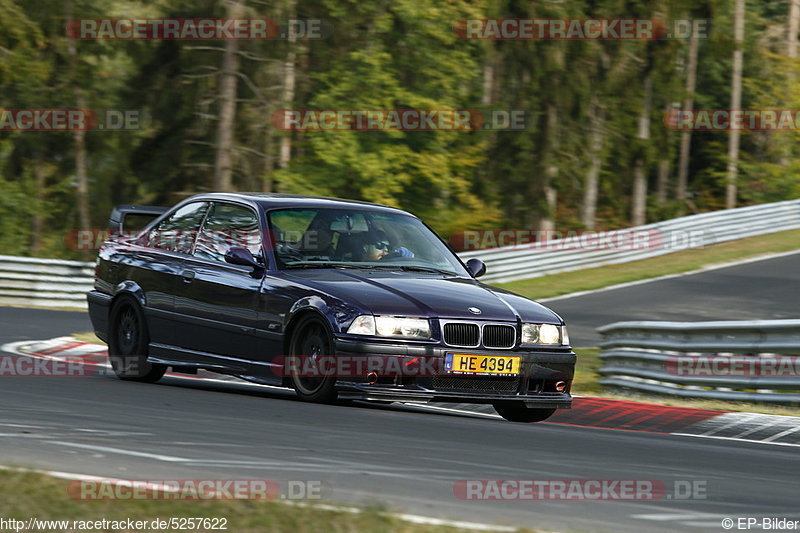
[288,269,562,324]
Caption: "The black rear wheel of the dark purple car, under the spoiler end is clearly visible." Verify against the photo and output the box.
[108,296,167,383]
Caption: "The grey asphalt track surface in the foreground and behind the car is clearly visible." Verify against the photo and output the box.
[0,252,800,532]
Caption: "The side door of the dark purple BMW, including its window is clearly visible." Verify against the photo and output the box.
[175,202,264,368]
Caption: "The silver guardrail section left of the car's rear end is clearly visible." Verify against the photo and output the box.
[0,255,94,309]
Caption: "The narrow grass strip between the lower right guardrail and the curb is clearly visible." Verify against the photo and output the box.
[572,348,800,416]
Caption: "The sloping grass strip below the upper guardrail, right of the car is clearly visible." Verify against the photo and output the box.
[498,230,800,299]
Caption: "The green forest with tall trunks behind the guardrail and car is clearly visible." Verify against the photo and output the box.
[0,0,800,259]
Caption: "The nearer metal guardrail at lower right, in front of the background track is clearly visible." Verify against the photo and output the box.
[597,320,800,404]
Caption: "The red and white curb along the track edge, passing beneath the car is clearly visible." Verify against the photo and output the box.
[0,337,800,446]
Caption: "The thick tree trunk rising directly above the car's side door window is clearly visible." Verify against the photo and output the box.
[213,0,244,191]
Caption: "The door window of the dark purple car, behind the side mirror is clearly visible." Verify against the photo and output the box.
[194,203,261,263]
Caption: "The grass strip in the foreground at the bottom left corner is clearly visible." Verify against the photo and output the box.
[0,471,531,533]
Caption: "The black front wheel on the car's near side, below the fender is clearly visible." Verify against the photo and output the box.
[289,316,338,403]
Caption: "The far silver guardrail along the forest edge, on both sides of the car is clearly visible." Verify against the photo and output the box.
[0,200,800,308]
